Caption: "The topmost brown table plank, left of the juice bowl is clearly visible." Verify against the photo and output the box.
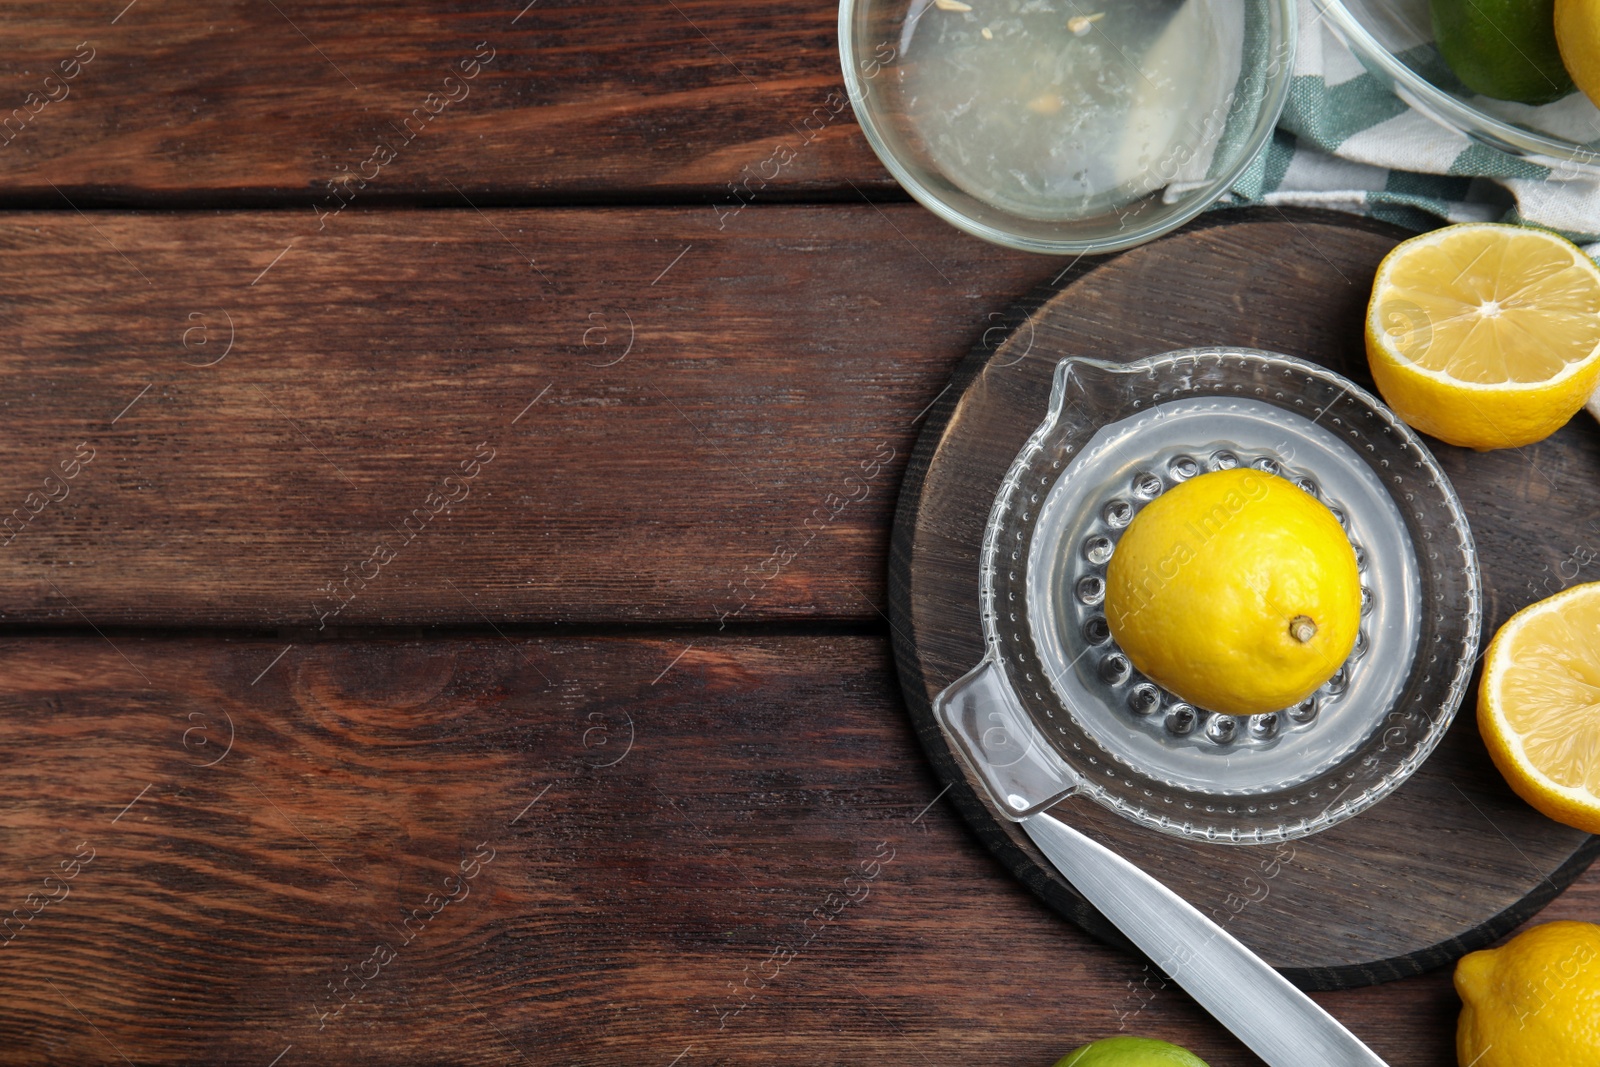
[0,0,896,204]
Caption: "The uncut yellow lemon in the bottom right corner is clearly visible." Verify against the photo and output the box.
[1456,921,1600,1067]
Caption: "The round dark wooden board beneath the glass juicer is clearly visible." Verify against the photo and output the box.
[890,208,1600,989]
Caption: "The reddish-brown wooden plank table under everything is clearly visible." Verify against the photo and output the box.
[0,0,1600,1067]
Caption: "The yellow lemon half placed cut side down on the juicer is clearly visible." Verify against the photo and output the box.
[1106,469,1362,715]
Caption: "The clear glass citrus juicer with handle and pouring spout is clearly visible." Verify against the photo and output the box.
[934,349,1482,845]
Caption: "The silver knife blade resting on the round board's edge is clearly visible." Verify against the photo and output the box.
[1021,811,1387,1067]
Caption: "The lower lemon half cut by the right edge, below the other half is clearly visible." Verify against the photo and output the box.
[1478,582,1600,833]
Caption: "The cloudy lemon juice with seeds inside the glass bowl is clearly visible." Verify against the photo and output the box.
[891,0,1245,219]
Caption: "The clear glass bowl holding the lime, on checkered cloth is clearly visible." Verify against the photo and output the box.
[1315,0,1600,178]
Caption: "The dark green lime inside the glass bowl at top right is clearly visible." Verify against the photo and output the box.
[1430,0,1573,104]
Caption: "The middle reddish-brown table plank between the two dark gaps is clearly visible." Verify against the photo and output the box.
[0,205,1059,629]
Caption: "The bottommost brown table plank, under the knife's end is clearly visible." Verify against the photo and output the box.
[0,637,1600,1067]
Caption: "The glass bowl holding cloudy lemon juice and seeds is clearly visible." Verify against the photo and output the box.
[838,0,1296,254]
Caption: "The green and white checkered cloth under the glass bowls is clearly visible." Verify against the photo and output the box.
[1224,0,1600,256]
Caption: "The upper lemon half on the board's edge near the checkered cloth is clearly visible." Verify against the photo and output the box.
[1366,222,1600,451]
